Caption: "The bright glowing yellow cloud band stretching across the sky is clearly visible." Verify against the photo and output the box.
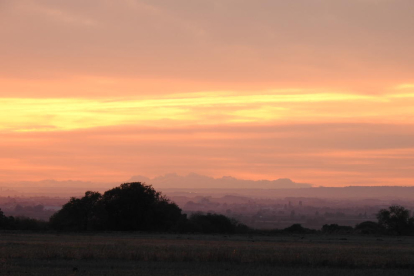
[0,90,414,132]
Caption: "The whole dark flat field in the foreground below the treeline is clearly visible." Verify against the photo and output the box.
[0,232,414,276]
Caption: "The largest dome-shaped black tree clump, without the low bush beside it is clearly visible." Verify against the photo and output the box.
[50,182,185,231]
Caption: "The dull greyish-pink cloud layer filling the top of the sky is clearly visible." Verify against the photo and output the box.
[0,0,414,86]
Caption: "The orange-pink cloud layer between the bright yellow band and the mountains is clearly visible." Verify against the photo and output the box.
[0,123,414,186]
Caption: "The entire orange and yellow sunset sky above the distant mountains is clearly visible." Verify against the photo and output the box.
[0,0,414,186]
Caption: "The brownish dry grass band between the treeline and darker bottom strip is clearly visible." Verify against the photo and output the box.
[0,233,414,269]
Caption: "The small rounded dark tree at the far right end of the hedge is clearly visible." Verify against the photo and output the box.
[377,205,414,235]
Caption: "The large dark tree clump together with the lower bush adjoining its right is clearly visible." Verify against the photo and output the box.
[49,182,248,234]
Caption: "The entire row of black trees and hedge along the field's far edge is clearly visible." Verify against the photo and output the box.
[0,182,414,235]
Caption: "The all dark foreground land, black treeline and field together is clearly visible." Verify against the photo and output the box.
[0,182,414,276]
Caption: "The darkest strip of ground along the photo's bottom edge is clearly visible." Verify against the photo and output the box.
[6,260,412,276]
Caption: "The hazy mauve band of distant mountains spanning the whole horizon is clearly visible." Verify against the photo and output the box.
[0,173,414,200]
